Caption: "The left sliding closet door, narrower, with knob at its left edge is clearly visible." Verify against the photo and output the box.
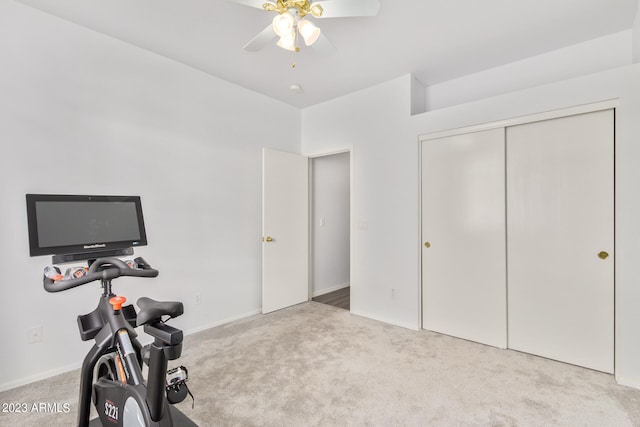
[422,129,507,348]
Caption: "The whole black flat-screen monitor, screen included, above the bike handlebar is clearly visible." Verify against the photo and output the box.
[27,194,147,259]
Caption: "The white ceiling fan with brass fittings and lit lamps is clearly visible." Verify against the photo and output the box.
[230,0,380,56]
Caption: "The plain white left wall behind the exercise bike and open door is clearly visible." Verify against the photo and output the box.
[0,1,300,389]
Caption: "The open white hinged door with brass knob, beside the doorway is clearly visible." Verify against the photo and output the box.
[262,148,309,313]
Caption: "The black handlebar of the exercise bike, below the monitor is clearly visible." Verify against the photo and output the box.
[43,258,158,292]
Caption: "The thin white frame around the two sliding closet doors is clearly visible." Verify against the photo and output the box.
[416,99,620,364]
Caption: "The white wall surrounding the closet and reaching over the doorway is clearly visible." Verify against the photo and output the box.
[302,64,640,387]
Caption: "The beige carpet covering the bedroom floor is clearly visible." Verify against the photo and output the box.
[0,302,640,427]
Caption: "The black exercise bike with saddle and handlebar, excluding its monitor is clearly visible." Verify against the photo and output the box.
[43,258,196,427]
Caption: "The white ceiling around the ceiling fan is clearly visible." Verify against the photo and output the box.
[19,0,638,107]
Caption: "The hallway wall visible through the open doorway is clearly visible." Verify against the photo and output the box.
[311,152,351,297]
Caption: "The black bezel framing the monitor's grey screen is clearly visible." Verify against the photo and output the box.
[26,194,147,256]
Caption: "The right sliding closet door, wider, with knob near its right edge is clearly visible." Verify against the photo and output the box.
[507,110,614,372]
